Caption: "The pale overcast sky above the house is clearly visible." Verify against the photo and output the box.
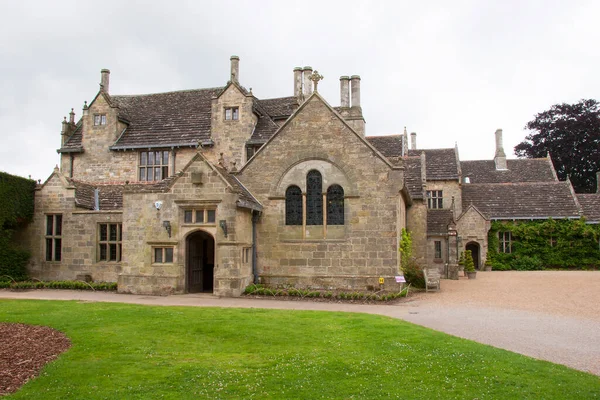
[0,0,600,180]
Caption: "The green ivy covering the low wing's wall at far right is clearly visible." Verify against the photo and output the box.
[488,218,600,270]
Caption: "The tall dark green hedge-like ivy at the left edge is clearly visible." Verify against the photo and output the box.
[0,172,35,281]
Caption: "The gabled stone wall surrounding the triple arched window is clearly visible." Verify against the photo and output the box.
[239,96,404,290]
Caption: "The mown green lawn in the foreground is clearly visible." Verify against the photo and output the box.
[0,300,600,399]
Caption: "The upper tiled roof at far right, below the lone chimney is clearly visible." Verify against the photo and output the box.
[462,158,557,183]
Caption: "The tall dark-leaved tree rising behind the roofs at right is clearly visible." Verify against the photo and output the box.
[515,99,600,193]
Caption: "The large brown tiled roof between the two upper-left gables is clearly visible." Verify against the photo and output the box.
[111,88,222,149]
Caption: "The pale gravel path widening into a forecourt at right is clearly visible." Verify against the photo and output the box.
[0,271,600,376]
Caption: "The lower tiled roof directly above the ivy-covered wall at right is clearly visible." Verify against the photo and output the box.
[462,182,579,219]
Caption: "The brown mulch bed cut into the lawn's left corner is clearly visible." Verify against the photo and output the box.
[0,323,71,396]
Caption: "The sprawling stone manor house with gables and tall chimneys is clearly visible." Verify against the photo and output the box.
[24,56,600,296]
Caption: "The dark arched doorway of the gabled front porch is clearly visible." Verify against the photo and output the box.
[186,231,215,293]
